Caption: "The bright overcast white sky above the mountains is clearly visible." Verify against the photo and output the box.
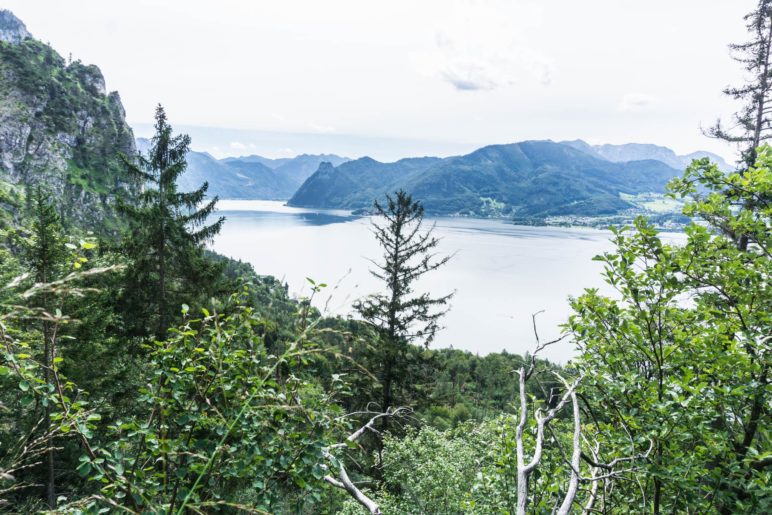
[0,0,756,161]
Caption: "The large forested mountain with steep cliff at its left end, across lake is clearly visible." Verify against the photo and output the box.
[288,141,682,219]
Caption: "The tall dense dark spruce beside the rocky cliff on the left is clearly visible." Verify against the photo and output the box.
[122,105,225,337]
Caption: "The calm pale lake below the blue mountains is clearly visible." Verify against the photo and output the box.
[213,200,612,362]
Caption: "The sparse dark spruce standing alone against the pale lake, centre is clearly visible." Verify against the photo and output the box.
[354,190,453,416]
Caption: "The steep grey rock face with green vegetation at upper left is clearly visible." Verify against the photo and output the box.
[0,11,135,231]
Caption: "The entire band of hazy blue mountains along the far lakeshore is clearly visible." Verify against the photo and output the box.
[169,139,730,219]
